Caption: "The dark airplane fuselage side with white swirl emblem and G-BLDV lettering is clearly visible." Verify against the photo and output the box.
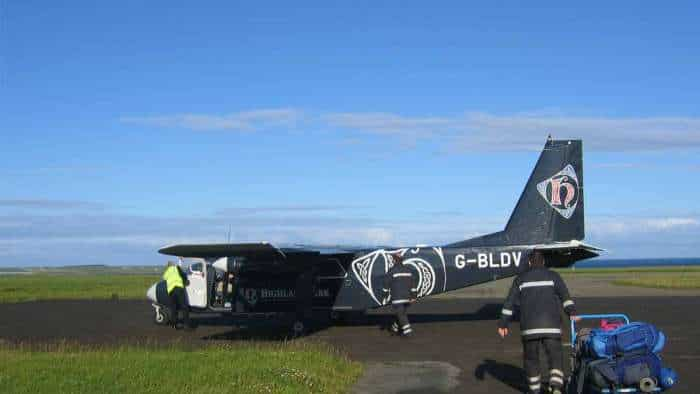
[205,246,532,312]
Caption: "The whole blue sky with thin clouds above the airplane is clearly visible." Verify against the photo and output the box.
[0,0,700,266]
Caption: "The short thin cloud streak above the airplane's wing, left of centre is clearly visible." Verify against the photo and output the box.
[120,108,302,132]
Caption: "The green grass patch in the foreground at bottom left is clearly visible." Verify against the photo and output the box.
[0,343,362,393]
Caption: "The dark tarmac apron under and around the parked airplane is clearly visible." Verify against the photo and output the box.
[0,296,700,394]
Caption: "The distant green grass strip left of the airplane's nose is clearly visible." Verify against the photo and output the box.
[0,273,159,302]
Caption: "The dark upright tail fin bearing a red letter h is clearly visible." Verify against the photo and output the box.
[503,138,584,245]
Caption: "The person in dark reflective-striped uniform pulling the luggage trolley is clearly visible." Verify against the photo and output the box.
[498,251,576,394]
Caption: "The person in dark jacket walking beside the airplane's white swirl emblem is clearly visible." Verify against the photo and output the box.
[383,253,417,337]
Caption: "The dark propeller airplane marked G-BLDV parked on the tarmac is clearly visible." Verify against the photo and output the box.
[147,136,603,332]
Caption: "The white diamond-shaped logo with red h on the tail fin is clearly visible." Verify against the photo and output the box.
[537,164,580,219]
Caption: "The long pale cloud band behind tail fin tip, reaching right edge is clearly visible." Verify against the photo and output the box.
[321,112,700,151]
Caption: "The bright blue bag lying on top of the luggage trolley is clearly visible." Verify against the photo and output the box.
[587,322,666,359]
